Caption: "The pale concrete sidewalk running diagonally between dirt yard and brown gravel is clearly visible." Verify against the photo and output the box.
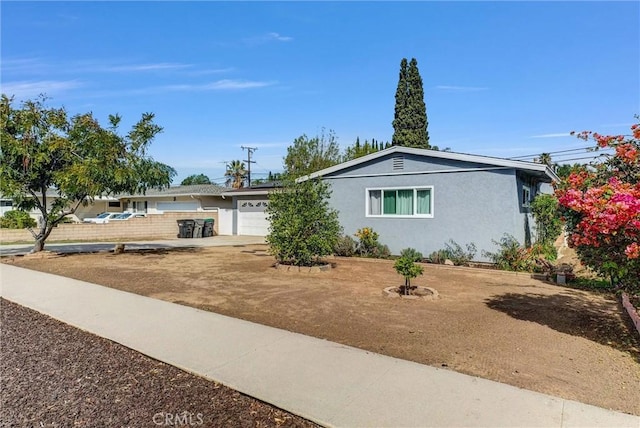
[0,264,640,428]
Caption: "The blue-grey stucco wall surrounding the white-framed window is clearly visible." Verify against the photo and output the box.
[324,166,533,261]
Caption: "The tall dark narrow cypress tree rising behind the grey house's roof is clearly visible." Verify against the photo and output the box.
[392,58,431,149]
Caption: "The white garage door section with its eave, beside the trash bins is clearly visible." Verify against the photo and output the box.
[223,182,281,236]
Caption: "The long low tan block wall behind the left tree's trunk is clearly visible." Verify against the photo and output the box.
[0,211,218,243]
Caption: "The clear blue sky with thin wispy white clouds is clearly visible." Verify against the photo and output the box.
[1,1,640,183]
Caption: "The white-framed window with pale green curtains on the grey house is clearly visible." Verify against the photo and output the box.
[365,186,433,218]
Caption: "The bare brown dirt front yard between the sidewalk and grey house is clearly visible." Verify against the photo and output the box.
[4,245,640,415]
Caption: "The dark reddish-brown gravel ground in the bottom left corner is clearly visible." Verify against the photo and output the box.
[0,299,317,427]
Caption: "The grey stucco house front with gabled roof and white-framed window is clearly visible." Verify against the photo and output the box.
[302,146,558,260]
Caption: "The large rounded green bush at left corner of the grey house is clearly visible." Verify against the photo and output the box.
[266,180,342,266]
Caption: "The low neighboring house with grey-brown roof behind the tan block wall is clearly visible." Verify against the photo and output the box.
[119,184,232,235]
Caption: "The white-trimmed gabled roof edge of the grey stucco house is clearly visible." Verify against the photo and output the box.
[297,146,560,181]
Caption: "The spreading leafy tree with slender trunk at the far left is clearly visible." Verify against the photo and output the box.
[0,94,176,252]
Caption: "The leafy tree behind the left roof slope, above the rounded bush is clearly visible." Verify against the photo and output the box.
[284,129,342,179]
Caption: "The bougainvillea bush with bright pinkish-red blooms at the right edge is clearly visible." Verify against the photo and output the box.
[556,120,640,293]
